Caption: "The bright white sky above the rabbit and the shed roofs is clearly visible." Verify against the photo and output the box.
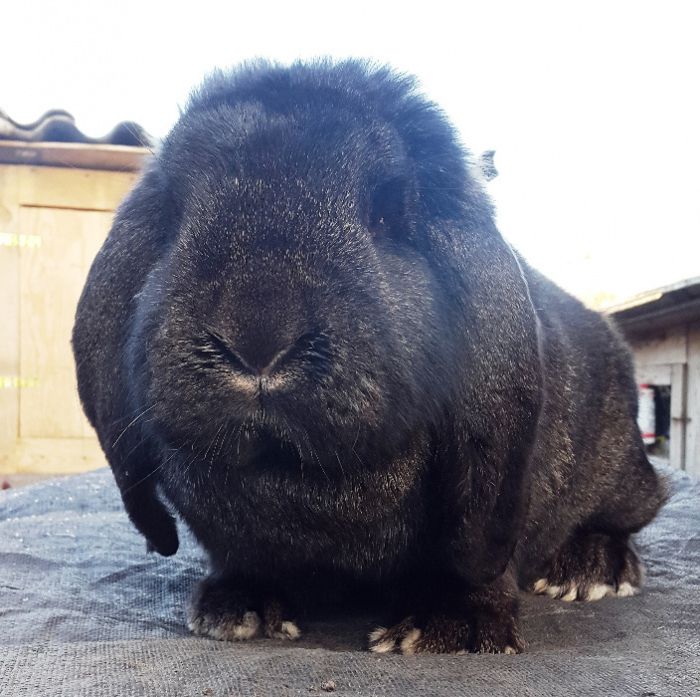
[0,0,700,299]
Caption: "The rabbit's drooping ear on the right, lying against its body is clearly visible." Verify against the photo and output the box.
[440,233,542,585]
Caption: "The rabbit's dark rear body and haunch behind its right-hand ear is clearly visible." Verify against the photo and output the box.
[515,268,665,599]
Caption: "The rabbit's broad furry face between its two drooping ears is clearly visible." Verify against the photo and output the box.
[135,61,488,474]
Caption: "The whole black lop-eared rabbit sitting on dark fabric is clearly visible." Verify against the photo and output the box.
[73,61,665,653]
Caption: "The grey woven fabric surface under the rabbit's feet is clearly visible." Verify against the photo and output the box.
[0,470,700,697]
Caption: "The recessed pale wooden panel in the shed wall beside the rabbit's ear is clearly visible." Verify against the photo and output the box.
[19,208,112,438]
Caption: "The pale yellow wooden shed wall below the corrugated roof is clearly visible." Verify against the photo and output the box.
[0,160,137,474]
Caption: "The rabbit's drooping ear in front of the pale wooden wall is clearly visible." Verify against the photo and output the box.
[73,163,178,555]
